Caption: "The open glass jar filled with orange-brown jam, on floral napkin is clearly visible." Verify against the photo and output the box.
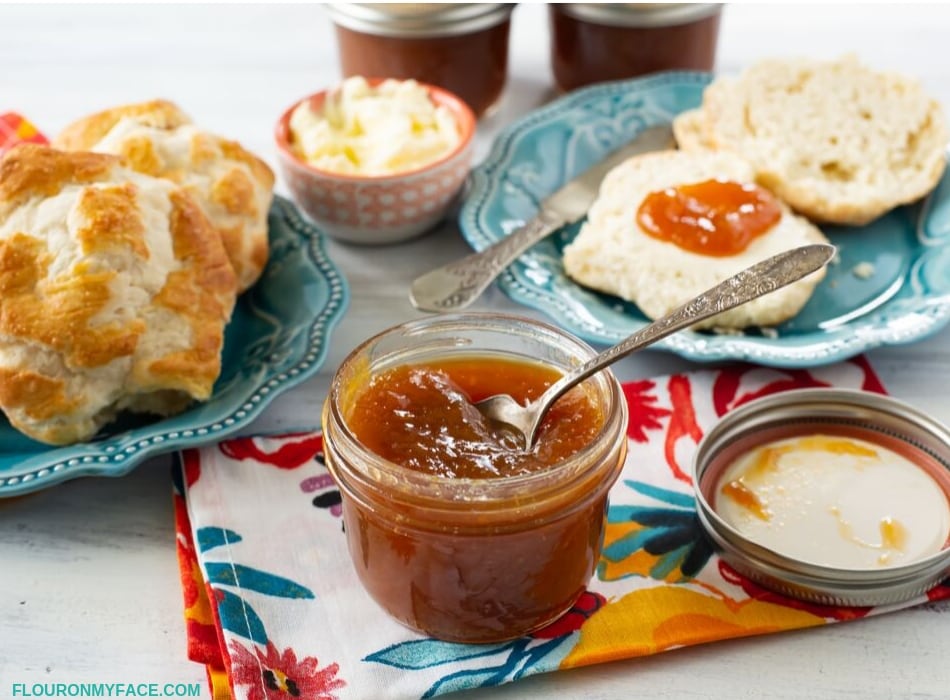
[323,314,627,643]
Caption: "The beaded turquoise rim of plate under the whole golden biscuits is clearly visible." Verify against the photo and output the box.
[0,195,349,497]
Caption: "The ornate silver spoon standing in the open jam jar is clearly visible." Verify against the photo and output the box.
[475,244,835,449]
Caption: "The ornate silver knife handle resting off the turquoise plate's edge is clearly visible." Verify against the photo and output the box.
[409,211,565,311]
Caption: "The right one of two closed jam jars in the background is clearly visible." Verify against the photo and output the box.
[549,3,722,90]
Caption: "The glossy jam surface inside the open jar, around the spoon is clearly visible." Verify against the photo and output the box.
[347,356,604,478]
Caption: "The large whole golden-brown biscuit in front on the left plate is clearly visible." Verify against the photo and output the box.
[0,145,237,445]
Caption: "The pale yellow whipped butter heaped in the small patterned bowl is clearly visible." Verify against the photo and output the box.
[289,76,461,177]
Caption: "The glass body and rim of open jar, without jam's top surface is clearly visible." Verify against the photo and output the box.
[323,313,627,643]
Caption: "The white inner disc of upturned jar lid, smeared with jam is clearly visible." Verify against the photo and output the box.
[715,434,950,569]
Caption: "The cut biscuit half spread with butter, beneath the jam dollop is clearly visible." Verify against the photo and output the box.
[564,151,827,329]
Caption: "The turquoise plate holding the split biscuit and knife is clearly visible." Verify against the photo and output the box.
[459,73,950,367]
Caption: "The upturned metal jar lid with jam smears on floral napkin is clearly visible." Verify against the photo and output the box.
[694,389,950,605]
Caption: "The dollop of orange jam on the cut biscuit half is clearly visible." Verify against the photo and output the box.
[637,180,782,257]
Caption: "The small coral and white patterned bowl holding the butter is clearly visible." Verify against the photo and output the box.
[275,85,476,245]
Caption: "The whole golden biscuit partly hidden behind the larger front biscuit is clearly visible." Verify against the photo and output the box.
[53,100,274,291]
